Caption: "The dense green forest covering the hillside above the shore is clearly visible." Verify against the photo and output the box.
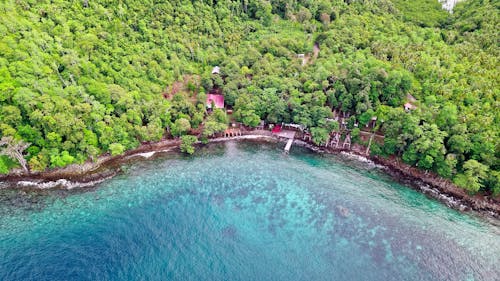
[0,0,500,194]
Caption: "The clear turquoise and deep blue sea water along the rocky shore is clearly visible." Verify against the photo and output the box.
[0,142,500,280]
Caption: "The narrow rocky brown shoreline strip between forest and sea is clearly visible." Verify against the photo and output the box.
[0,130,500,221]
